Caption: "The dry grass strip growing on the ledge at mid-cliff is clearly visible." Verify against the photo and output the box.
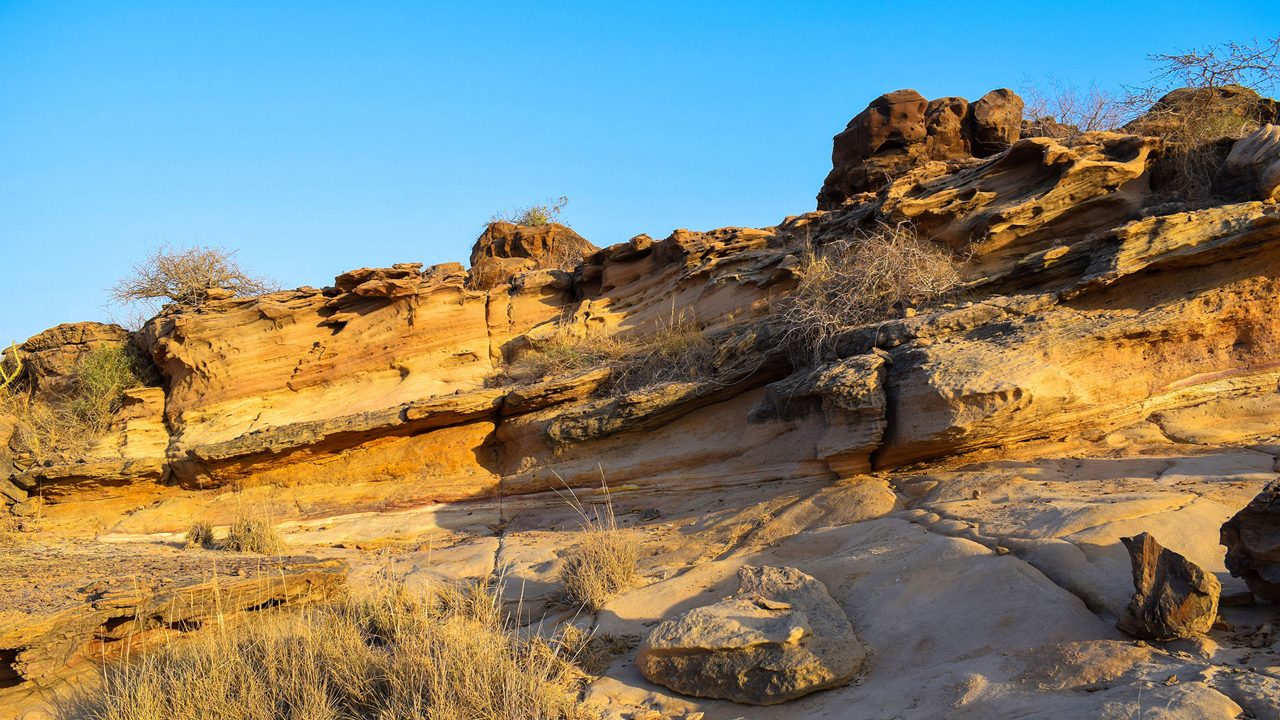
[508,314,718,395]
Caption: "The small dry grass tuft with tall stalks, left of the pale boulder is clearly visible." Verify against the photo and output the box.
[559,483,640,610]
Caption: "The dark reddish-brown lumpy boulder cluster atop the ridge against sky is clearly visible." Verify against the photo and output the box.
[818,88,1023,210]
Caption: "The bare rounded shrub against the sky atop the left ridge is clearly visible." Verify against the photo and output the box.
[111,245,274,307]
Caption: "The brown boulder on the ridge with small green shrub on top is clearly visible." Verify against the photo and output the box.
[467,222,598,290]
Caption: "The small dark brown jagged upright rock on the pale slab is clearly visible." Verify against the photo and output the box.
[1116,533,1222,641]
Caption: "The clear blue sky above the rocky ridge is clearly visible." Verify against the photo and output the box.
[0,0,1280,341]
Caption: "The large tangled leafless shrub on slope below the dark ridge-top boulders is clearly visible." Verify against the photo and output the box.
[780,225,960,363]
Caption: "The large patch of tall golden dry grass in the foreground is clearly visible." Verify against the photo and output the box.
[58,585,589,720]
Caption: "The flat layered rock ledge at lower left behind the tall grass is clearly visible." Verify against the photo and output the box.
[0,544,347,712]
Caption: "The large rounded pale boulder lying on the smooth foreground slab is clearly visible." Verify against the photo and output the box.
[636,566,867,705]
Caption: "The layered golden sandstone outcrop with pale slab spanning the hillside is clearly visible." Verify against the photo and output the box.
[0,81,1280,719]
